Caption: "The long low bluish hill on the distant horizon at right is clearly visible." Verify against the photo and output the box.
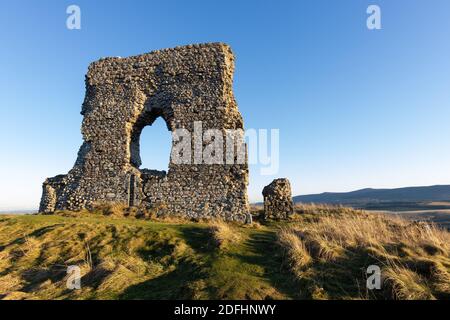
[293,185,450,208]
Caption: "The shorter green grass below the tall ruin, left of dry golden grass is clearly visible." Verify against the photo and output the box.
[0,215,298,299]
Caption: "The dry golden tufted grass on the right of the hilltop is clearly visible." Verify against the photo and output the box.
[278,206,450,299]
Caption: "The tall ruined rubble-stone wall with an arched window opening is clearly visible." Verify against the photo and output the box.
[39,43,249,220]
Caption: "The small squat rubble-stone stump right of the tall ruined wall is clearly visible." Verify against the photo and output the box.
[262,178,294,219]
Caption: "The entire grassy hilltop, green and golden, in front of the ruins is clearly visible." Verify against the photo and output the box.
[0,206,450,299]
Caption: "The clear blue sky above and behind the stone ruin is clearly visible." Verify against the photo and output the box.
[0,0,450,210]
